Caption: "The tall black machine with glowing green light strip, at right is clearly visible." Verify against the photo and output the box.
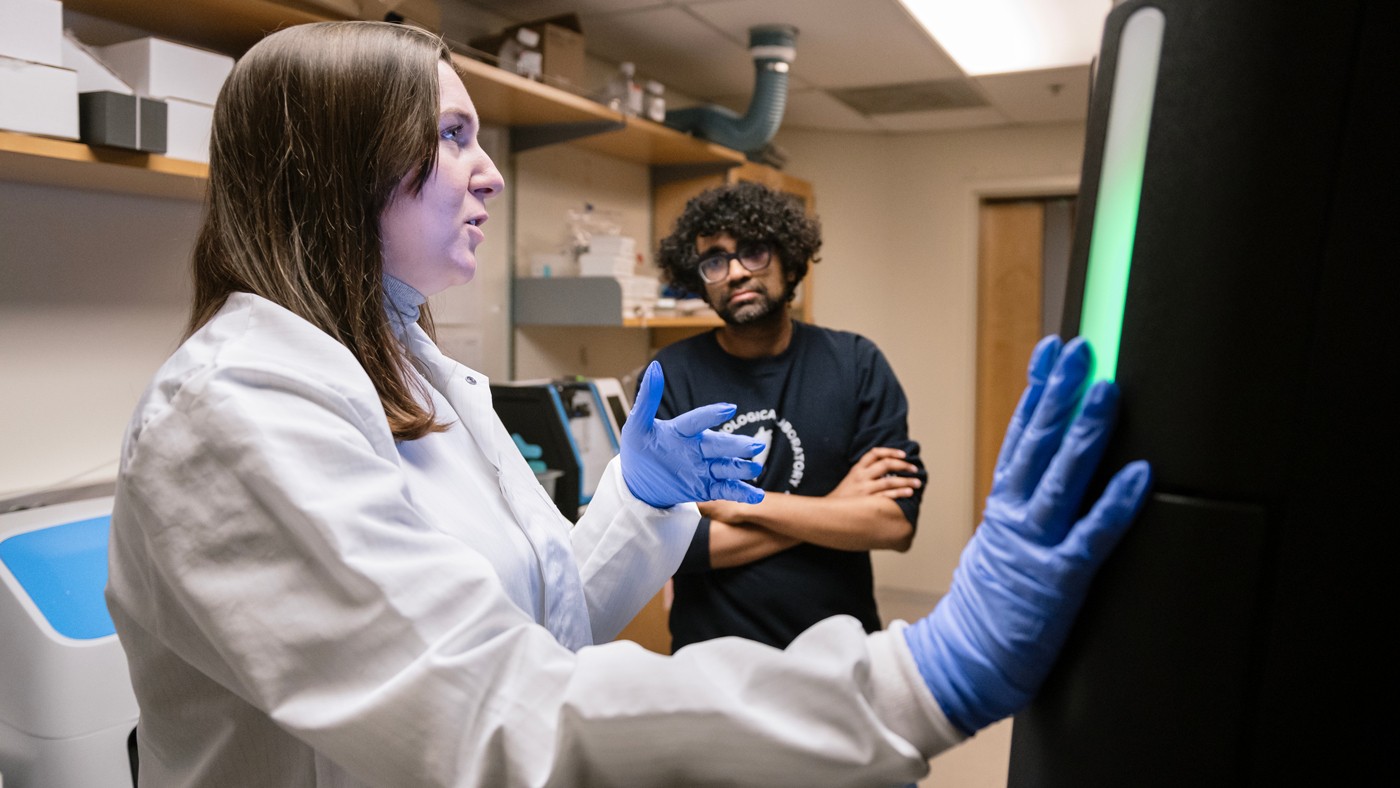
[1008,0,1400,788]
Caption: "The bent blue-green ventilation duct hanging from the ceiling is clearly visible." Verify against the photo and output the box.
[666,25,797,153]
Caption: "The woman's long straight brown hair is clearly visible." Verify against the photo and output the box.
[188,22,451,439]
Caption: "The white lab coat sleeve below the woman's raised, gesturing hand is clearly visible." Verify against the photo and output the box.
[571,458,700,642]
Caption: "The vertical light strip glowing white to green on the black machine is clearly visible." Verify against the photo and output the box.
[1079,8,1166,381]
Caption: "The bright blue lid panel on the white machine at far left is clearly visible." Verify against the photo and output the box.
[0,515,116,640]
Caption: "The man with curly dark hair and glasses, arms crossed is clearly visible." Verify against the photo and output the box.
[657,182,927,651]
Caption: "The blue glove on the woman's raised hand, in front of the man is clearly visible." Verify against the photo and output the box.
[620,361,763,508]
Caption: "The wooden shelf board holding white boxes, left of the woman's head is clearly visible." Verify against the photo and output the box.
[0,130,209,200]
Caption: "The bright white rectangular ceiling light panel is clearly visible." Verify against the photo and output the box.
[900,0,1113,77]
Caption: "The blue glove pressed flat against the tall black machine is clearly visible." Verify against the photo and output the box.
[904,337,1151,735]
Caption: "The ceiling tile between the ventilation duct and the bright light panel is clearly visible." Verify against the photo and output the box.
[687,0,962,88]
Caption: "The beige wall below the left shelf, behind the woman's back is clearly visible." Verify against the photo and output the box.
[0,182,200,498]
